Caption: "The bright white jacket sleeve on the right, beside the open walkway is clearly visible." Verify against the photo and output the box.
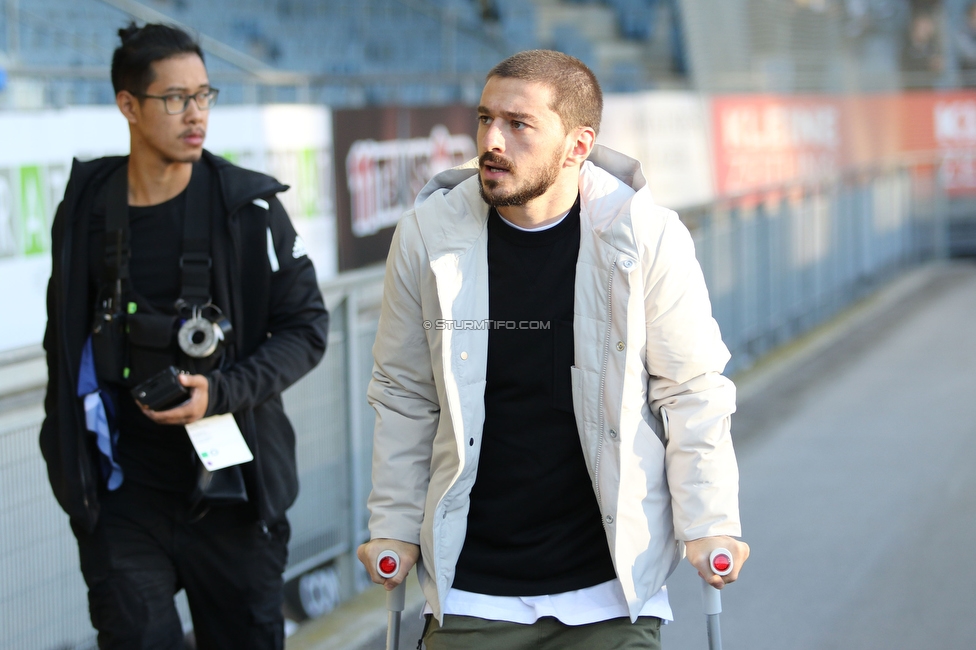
[644,212,741,541]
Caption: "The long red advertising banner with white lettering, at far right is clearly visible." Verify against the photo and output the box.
[711,91,976,196]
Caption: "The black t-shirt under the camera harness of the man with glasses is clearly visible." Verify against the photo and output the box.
[88,190,197,494]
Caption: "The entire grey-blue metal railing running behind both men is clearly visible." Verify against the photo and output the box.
[0,154,947,650]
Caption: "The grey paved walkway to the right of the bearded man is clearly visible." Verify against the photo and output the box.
[664,263,976,650]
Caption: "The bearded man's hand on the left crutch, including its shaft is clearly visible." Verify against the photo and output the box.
[356,539,420,650]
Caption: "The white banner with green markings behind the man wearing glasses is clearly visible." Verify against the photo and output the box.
[0,105,337,352]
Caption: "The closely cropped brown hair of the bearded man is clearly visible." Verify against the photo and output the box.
[486,50,603,133]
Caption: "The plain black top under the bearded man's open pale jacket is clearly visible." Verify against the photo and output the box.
[453,200,616,596]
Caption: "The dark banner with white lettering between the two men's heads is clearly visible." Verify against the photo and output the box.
[332,106,478,271]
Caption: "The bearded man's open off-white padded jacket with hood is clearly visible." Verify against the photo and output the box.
[367,146,741,620]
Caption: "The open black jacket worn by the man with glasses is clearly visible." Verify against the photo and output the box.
[40,151,329,531]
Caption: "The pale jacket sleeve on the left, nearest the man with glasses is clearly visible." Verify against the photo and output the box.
[366,212,440,544]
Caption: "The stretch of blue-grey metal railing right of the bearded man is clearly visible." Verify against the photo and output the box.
[682,154,948,375]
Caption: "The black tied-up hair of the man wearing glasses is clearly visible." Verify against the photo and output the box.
[112,22,203,95]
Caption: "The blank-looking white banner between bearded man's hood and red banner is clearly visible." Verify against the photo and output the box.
[597,91,715,210]
